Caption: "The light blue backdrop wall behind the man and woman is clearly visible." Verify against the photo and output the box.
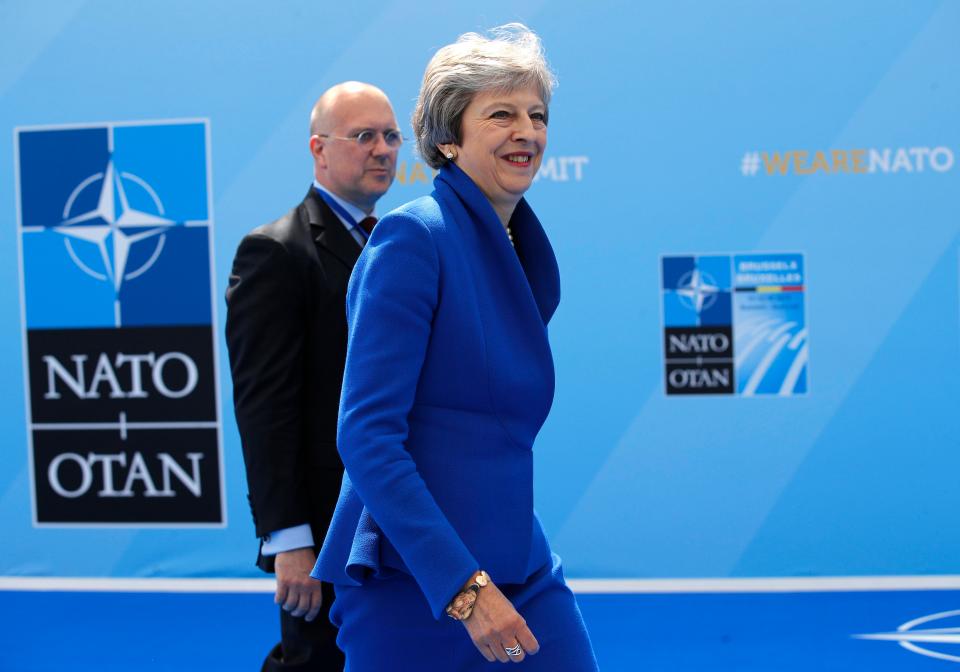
[0,0,960,578]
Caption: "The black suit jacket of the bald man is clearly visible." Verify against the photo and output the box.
[227,188,360,571]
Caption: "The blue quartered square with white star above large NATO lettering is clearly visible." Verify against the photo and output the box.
[16,121,212,329]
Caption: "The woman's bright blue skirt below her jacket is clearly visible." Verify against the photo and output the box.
[330,555,598,672]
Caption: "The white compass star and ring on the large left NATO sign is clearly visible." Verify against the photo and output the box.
[54,159,176,292]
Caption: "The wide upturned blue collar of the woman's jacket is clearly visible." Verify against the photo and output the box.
[433,163,560,326]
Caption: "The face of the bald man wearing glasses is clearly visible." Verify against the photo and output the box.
[310,89,399,212]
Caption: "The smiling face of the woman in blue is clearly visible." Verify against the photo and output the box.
[456,86,547,221]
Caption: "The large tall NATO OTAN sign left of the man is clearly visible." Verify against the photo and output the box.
[16,120,224,526]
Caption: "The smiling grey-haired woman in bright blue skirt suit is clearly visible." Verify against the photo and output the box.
[314,24,596,672]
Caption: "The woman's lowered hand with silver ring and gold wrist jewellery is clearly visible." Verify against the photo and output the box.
[461,581,540,663]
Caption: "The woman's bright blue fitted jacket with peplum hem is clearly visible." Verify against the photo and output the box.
[313,164,560,618]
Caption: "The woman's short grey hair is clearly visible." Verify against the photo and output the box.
[413,23,556,168]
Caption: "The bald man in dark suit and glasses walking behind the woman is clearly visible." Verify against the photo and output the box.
[227,82,402,671]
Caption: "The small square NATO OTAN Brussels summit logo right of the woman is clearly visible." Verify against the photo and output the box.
[660,253,807,397]
